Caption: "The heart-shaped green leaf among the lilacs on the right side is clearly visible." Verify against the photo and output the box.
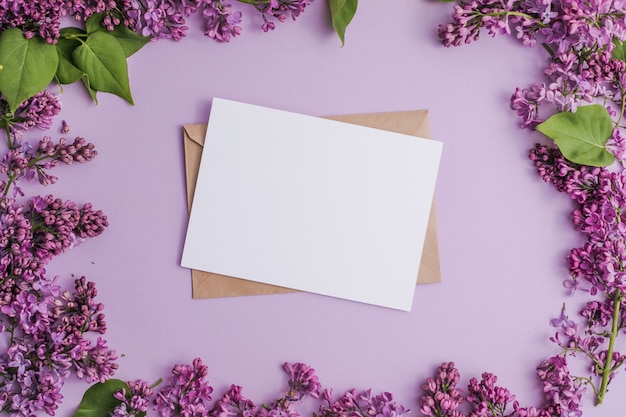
[537,104,615,166]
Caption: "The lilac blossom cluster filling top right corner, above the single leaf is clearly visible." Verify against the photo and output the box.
[439,0,626,129]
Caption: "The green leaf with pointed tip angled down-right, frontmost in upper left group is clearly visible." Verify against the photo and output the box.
[72,32,133,104]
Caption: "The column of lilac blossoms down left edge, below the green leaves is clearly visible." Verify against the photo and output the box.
[0,82,117,417]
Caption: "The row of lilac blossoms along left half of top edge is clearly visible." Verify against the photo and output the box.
[0,0,311,43]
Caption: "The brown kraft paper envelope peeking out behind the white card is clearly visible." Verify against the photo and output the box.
[183,110,441,298]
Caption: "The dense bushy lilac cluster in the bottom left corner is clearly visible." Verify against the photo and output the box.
[0,276,117,417]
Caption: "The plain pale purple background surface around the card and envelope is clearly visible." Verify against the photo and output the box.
[35,0,626,416]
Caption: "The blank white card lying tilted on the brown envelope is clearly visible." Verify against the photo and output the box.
[181,98,442,311]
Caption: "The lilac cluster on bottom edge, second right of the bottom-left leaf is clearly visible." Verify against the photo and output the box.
[154,358,213,417]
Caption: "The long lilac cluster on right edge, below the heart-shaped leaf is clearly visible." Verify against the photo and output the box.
[530,145,626,402]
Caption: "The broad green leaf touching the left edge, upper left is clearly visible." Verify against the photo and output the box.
[0,28,59,112]
